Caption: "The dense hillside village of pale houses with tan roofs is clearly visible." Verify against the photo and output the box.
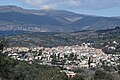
[3,43,119,70]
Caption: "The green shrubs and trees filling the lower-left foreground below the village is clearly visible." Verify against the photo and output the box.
[0,39,67,80]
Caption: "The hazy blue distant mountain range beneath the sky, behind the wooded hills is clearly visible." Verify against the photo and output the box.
[0,5,120,32]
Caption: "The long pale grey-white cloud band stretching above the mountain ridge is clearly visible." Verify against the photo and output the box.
[22,0,120,9]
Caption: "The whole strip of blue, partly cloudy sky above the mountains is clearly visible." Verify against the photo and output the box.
[0,0,120,17]
